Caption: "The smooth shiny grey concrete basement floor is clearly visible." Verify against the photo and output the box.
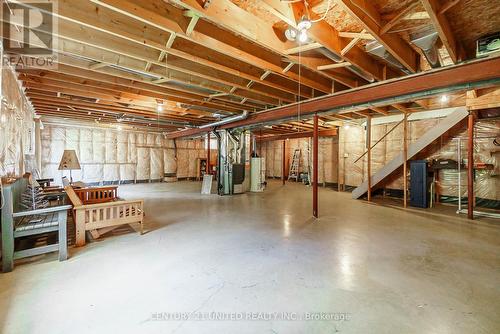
[0,182,500,334]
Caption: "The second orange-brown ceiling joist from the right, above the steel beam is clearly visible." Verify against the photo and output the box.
[337,0,419,73]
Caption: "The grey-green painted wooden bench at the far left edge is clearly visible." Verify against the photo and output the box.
[1,178,71,272]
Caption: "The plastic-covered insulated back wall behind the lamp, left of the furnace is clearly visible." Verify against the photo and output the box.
[41,124,209,184]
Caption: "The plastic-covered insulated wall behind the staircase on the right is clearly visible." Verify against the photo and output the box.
[339,118,500,201]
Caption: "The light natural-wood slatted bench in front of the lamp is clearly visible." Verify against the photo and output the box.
[64,186,144,246]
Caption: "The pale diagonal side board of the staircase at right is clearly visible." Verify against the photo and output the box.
[352,107,469,199]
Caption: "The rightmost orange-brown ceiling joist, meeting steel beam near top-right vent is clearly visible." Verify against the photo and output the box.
[421,0,461,64]
